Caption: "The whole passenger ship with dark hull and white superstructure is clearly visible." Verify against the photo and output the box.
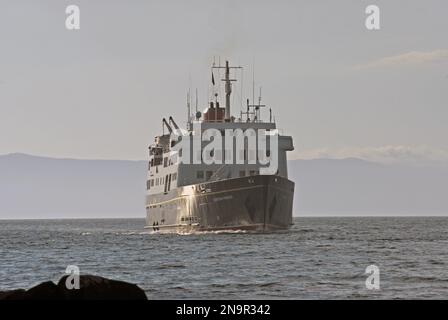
[145,61,294,232]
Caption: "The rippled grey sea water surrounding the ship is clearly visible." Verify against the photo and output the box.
[0,218,448,299]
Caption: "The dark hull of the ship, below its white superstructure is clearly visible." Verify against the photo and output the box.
[146,175,294,232]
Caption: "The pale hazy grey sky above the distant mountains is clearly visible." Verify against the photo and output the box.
[0,0,448,160]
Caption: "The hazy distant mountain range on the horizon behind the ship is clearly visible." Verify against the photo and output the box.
[0,154,448,219]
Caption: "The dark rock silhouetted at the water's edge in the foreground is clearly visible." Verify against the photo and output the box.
[0,275,147,300]
